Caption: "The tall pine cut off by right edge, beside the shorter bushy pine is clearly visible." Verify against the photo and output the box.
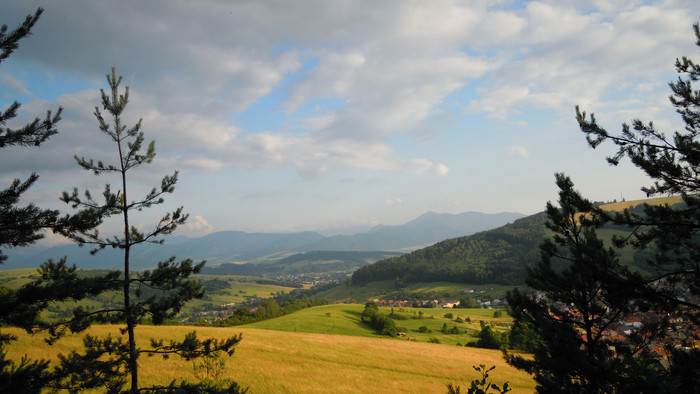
[576,24,700,392]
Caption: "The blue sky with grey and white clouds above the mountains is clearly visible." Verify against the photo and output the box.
[0,0,700,242]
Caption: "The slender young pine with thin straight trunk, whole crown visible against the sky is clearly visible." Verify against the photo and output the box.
[51,68,241,393]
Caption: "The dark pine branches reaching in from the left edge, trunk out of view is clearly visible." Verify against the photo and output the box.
[0,8,95,392]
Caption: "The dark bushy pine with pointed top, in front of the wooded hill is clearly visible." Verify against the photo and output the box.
[506,174,656,393]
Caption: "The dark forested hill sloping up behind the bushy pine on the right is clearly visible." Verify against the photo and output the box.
[352,212,547,284]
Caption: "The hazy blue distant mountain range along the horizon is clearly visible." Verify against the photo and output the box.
[0,212,525,269]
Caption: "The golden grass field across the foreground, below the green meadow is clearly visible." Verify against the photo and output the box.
[2,325,534,393]
